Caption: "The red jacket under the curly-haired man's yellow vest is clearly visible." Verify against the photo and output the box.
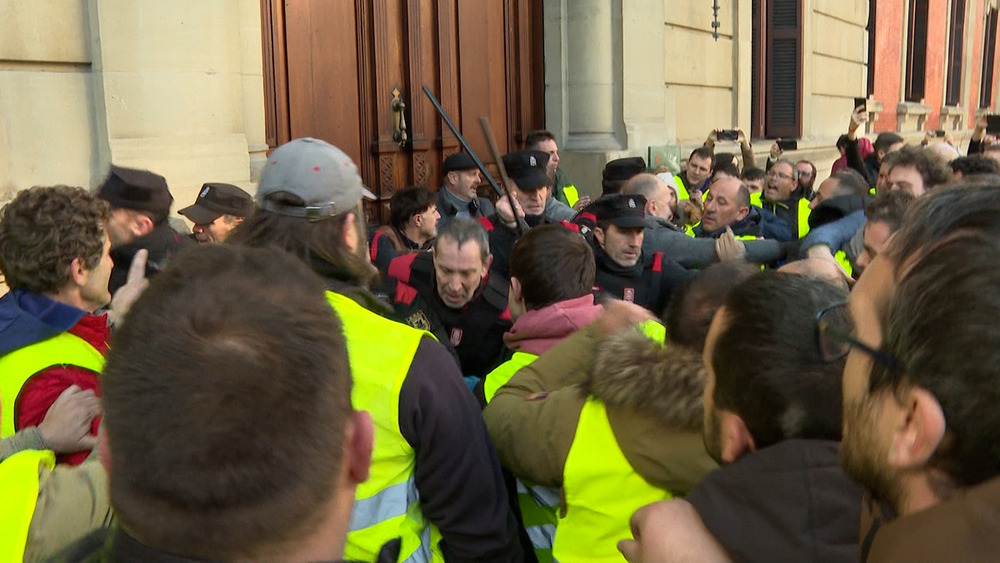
[14,315,111,465]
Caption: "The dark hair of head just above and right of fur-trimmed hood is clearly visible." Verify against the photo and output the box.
[663,260,759,353]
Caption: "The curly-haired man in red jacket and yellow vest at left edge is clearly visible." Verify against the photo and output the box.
[0,186,114,465]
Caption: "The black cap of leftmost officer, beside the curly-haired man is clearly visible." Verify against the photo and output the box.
[97,164,174,225]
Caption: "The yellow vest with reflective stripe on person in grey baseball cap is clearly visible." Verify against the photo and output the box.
[326,291,444,562]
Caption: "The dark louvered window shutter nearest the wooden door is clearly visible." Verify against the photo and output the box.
[765,0,802,137]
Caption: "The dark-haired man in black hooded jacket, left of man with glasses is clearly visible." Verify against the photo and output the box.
[619,271,863,561]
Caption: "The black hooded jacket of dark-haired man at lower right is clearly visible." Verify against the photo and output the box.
[687,440,864,562]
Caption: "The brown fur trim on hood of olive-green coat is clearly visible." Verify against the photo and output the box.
[584,329,705,431]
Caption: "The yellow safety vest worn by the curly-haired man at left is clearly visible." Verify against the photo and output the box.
[0,332,104,438]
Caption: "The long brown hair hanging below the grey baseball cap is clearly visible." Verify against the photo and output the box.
[226,203,378,287]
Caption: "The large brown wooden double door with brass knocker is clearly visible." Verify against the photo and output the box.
[261,0,544,221]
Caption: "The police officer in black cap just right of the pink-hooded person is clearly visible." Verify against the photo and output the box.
[591,194,693,315]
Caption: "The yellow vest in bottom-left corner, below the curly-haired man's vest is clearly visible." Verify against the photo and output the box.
[0,450,56,561]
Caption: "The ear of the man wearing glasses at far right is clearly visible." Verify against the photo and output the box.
[885,387,947,469]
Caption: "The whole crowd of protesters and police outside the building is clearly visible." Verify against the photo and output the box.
[0,108,1000,562]
